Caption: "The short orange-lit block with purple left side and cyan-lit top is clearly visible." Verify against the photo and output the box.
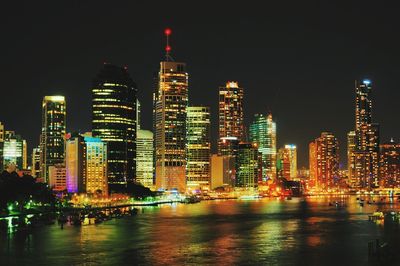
[65,135,108,195]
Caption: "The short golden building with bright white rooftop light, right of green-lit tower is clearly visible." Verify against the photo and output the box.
[277,144,297,180]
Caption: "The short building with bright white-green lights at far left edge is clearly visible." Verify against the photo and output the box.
[2,131,28,170]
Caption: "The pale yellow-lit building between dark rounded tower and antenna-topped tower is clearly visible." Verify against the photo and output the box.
[136,129,154,188]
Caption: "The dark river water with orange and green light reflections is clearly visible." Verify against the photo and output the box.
[0,196,400,265]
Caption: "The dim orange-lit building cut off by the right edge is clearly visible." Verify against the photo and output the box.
[380,139,400,188]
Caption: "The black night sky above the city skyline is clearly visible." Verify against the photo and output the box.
[0,0,400,166]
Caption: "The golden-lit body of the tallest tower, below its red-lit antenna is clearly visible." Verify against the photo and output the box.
[153,60,189,192]
